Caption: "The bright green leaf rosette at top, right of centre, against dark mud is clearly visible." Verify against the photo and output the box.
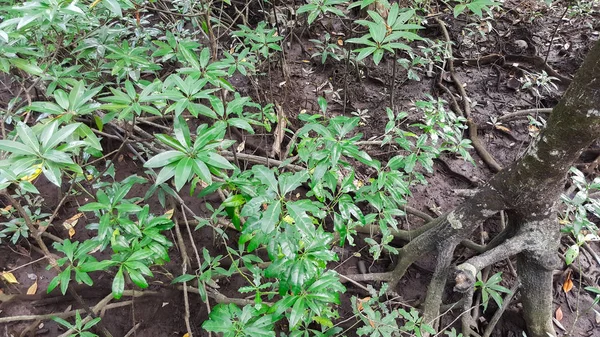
[346,3,423,65]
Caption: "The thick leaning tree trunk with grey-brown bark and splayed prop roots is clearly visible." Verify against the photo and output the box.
[346,41,600,337]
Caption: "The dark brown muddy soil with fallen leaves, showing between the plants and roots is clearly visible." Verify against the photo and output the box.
[0,0,600,337]
